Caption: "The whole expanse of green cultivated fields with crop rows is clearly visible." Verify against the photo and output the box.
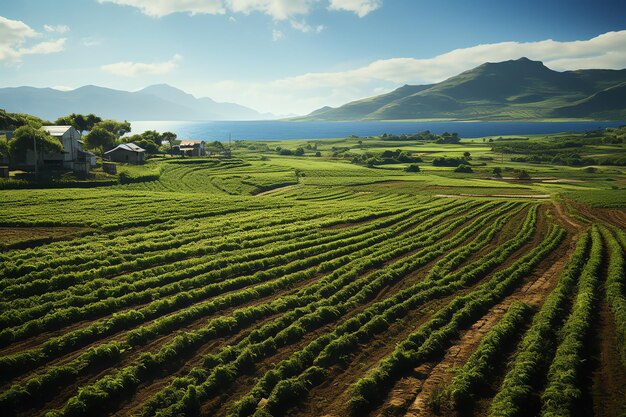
[0,131,626,417]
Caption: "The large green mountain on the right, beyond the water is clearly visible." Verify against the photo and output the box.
[291,58,626,121]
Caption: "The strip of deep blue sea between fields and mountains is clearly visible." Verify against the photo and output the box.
[131,121,626,141]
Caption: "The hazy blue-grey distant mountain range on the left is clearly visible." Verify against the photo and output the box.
[0,84,276,120]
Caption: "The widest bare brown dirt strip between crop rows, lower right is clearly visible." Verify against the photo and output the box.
[394,228,576,417]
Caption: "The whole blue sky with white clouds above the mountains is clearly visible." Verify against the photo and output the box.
[0,0,626,115]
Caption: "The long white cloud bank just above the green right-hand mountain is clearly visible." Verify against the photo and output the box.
[201,30,626,114]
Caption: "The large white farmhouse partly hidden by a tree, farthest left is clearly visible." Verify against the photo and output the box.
[39,126,89,172]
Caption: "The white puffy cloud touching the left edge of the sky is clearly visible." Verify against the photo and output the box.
[0,16,65,63]
